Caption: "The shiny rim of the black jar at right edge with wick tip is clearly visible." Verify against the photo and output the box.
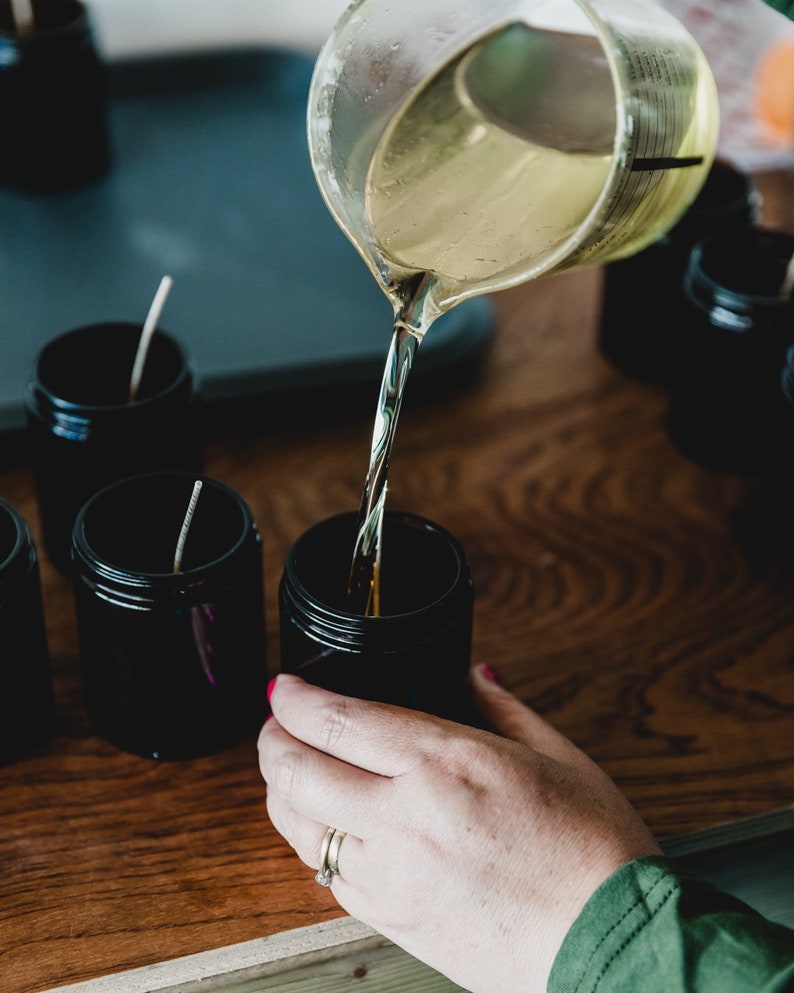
[684,225,794,331]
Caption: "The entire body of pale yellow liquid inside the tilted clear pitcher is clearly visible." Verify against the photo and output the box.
[364,24,719,314]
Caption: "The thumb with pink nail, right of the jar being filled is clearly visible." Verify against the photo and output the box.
[471,665,590,765]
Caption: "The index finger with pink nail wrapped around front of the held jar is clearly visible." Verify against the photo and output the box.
[270,673,445,777]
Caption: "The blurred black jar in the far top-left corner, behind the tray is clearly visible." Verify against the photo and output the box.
[0,0,111,193]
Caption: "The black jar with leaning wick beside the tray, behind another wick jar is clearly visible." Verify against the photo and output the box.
[25,322,203,572]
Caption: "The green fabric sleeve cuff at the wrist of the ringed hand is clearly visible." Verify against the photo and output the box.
[548,858,794,993]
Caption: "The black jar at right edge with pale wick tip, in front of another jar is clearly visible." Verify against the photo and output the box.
[667,227,794,475]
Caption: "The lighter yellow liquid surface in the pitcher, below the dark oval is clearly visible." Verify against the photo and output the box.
[365,41,611,310]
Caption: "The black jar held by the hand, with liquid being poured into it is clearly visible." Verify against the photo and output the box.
[279,511,474,721]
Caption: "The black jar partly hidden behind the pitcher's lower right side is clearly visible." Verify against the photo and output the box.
[598,159,760,386]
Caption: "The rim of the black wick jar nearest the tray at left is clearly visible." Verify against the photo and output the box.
[25,321,194,435]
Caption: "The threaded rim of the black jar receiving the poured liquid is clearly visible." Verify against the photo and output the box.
[280,510,473,647]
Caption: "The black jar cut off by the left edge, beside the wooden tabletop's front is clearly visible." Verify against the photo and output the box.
[0,499,55,763]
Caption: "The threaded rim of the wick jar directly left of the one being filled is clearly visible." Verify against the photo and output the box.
[72,470,255,600]
